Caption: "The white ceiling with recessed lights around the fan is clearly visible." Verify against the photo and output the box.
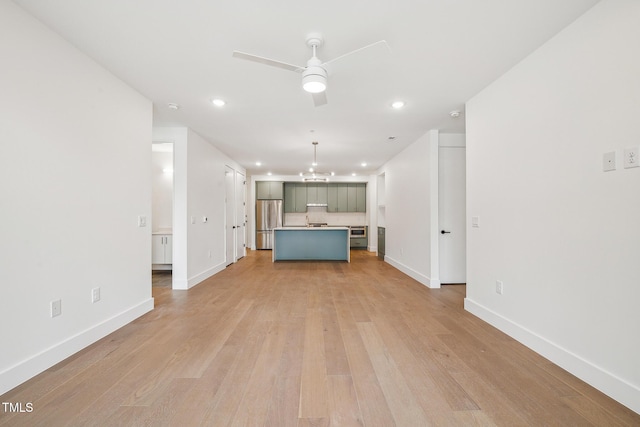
[15,0,597,175]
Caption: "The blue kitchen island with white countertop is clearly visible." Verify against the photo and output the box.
[272,227,350,262]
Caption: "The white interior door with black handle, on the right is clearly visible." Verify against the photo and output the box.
[438,146,467,284]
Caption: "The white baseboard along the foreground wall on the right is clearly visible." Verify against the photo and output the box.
[464,298,640,413]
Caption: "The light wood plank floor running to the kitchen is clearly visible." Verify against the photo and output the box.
[0,251,640,427]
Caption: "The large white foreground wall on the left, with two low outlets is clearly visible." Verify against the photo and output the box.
[0,2,153,394]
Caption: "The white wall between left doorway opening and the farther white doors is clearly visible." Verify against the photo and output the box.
[153,128,245,289]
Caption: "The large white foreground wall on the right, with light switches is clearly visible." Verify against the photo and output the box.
[465,0,640,412]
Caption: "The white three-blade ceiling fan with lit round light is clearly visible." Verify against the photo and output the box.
[233,33,389,107]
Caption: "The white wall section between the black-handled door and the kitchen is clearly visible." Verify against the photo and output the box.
[378,131,440,287]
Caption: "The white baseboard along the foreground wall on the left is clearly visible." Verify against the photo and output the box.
[0,298,153,394]
